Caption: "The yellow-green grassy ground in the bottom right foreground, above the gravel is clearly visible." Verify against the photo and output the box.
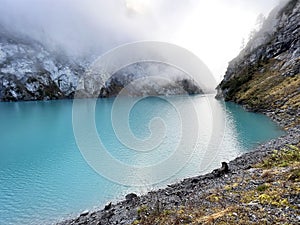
[132,143,300,225]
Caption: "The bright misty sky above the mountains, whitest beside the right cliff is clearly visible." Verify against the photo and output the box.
[0,0,280,80]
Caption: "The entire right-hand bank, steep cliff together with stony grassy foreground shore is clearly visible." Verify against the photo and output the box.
[59,0,300,222]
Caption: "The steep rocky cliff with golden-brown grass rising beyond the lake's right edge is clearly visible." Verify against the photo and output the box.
[217,0,300,128]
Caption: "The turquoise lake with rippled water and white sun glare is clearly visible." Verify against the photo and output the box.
[0,95,284,225]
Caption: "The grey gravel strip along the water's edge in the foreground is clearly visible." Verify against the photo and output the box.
[58,122,300,225]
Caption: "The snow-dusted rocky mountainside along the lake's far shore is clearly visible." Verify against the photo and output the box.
[0,27,202,101]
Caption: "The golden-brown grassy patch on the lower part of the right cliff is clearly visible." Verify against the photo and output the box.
[221,59,300,128]
